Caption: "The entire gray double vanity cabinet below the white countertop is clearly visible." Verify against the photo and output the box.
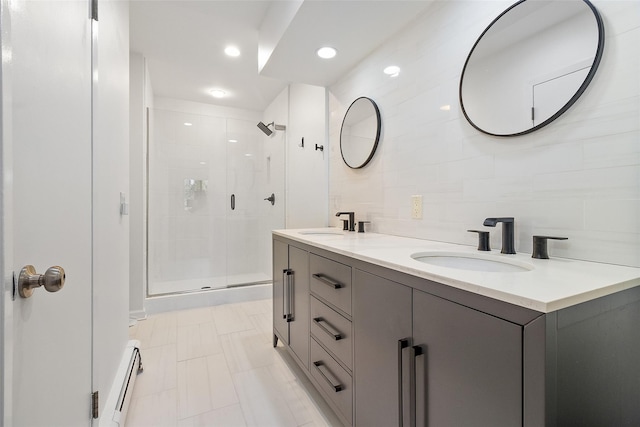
[273,236,640,427]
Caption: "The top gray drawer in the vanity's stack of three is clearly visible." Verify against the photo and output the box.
[309,254,351,315]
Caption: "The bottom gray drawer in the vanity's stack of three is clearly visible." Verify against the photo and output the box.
[309,339,353,424]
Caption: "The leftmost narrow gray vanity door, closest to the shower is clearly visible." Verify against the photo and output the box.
[273,240,289,347]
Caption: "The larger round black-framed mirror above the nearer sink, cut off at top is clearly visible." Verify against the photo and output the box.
[460,0,604,136]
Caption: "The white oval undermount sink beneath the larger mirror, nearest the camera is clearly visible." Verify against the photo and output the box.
[411,252,534,273]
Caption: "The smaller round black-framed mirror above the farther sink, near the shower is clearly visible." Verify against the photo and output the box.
[340,97,380,169]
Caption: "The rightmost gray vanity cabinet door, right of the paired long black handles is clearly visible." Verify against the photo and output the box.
[412,290,522,427]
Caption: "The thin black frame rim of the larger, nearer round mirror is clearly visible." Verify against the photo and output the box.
[458,0,604,136]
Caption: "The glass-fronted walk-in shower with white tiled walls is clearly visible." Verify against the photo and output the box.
[147,109,285,296]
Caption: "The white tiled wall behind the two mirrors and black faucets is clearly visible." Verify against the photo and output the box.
[329,0,640,266]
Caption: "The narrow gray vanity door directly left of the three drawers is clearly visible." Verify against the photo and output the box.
[289,246,309,369]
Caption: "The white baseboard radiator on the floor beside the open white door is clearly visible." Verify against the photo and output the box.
[99,340,143,427]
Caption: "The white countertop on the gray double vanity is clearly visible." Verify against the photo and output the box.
[273,228,640,313]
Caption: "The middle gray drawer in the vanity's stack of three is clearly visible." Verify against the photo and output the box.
[311,297,353,369]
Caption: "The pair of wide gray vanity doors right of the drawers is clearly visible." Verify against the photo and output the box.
[353,270,522,427]
